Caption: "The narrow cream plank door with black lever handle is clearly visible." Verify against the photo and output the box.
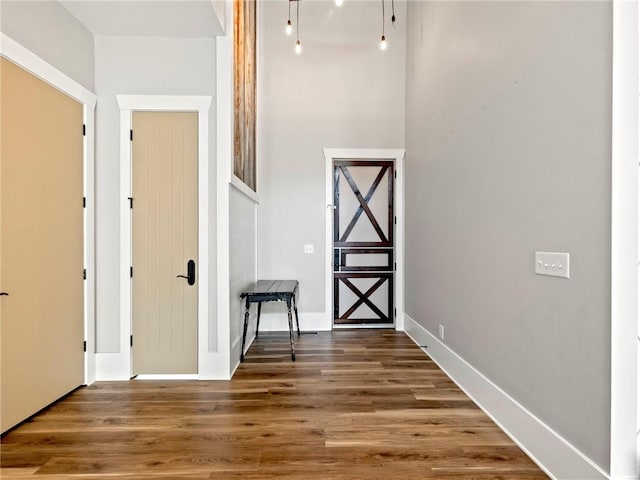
[132,112,198,375]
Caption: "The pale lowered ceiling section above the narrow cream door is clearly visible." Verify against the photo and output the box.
[59,0,225,37]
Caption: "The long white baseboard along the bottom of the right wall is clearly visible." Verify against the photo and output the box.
[404,314,608,480]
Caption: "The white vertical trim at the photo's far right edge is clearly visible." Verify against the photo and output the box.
[610,0,640,480]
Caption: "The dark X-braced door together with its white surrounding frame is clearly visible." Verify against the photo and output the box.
[324,149,404,330]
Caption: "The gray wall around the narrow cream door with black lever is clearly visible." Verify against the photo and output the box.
[95,36,217,353]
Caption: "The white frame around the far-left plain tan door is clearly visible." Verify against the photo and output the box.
[0,32,96,385]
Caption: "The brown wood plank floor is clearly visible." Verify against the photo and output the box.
[0,330,548,480]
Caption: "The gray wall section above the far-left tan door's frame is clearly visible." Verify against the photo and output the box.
[0,0,94,91]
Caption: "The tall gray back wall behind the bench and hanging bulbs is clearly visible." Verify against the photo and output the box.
[258,1,407,318]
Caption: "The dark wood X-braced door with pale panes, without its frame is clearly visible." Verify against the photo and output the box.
[333,160,394,326]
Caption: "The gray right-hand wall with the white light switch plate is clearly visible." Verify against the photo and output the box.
[406,2,612,470]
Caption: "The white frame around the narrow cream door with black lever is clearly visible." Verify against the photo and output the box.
[116,95,212,379]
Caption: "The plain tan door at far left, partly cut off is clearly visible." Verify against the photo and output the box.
[0,58,84,432]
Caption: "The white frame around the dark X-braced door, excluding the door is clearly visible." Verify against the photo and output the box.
[323,148,404,331]
